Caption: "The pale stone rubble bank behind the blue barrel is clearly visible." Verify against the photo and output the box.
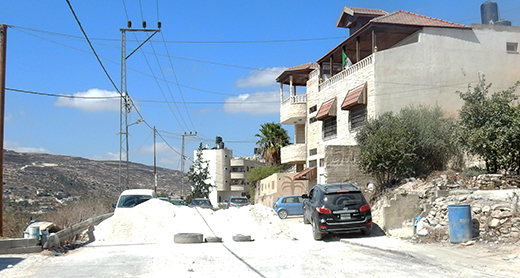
[375,174,520,242]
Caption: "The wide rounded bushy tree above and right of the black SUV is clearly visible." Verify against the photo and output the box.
[356,106,458,190]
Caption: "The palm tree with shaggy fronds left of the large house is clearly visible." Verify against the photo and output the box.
[255,122,290,165]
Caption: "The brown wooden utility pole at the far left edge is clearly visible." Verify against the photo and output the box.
[0,24,7,236]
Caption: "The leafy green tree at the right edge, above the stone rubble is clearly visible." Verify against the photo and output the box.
[457,80,520,173]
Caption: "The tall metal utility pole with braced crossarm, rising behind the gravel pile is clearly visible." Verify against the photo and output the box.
[119,21,161,190]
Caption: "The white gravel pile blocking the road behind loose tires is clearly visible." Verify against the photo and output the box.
[94,199,293,243]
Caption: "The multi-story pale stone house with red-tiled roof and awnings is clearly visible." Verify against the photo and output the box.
[277,7,520,189]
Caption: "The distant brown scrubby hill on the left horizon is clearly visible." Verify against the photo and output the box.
[3,150,187,212]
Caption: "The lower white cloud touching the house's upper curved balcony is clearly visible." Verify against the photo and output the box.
[224,92,280,115]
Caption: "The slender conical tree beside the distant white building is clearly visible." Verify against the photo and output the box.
[186,143,213,203]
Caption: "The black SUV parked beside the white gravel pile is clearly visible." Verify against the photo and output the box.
[302,183,372,240]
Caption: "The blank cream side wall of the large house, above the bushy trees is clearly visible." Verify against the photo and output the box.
[376,25,520,116]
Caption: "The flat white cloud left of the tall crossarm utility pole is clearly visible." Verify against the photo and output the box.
[54,89,120,111]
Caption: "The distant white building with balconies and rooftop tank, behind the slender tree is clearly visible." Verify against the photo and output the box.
[199,136,264,205]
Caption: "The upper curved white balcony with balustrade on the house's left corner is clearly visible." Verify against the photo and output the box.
[280,95,307,125]
